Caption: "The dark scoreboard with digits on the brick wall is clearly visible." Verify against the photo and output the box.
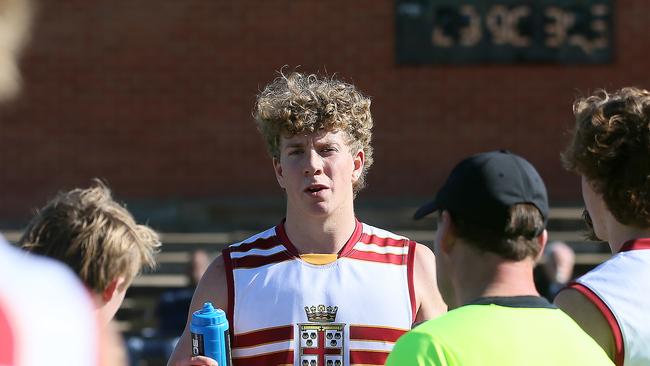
[395,0,614,64]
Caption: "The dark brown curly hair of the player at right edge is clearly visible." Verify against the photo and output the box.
[562,87,650,228]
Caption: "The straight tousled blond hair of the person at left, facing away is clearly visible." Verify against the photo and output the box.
[19,180,160,293]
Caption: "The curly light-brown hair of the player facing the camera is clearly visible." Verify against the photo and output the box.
[253,72,373,193]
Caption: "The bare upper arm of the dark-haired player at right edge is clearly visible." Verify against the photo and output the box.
[554,288,616,360]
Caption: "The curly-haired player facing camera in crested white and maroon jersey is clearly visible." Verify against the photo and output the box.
[169,73,446,366]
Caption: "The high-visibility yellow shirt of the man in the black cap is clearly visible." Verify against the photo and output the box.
[386,296,613,366]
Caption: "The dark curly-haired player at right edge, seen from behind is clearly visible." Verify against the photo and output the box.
[555,88,650,366]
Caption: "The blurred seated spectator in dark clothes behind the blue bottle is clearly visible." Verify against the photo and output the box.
[127,250,210,366]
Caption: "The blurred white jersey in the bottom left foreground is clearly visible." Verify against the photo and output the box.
[0,236,99,366]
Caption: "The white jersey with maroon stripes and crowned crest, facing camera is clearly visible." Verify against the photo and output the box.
[223,222,416,366]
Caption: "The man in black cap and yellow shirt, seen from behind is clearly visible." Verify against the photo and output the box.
[386,151,612,366]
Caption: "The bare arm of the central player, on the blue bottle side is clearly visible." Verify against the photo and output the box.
[167,256,228,366]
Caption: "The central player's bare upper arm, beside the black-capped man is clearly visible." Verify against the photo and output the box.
[413,244,447,324]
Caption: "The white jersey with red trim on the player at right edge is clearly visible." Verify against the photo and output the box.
[570,239,650,366]
